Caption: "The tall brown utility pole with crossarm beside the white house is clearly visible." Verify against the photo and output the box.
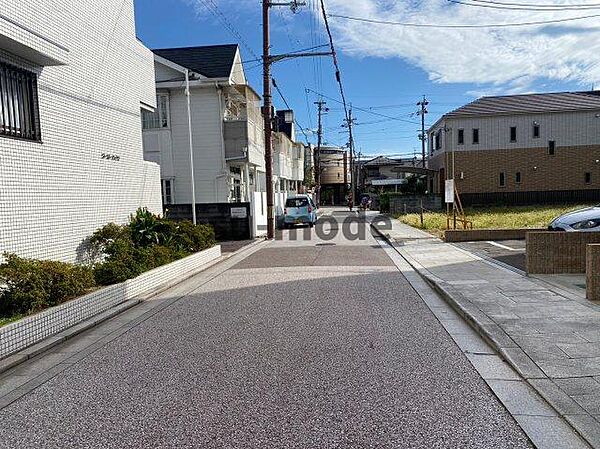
[262,0,332,239]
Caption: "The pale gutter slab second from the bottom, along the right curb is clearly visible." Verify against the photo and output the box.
[487,380,556,416]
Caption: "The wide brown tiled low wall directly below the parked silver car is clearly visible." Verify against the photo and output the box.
[526,231,600,274]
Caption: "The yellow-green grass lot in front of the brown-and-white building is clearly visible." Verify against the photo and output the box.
[396,205,589,235]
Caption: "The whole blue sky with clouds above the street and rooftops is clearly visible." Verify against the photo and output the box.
[134,0,600,157]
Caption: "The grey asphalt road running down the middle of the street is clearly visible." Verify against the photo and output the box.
[0,210,531,449]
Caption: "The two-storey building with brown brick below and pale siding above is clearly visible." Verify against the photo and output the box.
[428,91,600,203]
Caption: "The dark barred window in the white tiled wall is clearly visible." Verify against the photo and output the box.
[0,62,42,141]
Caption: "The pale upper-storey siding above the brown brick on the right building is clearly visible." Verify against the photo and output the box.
[431,111,600,153]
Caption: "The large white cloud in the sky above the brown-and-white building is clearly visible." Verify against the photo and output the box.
[327,0,600,94]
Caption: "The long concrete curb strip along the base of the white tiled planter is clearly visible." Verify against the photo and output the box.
[0,239,267,375]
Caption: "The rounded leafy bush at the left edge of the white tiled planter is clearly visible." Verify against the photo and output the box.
[0,254,95,316]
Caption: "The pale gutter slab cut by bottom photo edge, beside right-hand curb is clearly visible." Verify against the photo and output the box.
[515,415,589,449]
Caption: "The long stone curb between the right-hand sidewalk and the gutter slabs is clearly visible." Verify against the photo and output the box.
[371,223,600,449]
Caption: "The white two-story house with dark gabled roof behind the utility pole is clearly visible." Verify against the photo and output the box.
[142,44,266,234]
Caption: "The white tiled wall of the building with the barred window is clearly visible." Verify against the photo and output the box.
[0,0,161,262]
